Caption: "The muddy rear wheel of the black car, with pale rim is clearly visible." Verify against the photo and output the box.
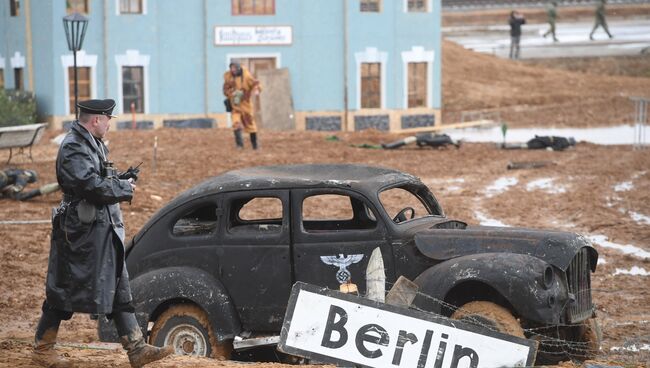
[150,304,232,359]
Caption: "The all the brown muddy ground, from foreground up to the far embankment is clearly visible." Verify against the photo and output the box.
[0,6,650,367]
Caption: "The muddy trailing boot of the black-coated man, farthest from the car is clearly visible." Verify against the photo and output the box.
[32,310,74,368]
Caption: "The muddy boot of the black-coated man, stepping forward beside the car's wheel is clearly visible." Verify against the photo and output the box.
[113,312,174,368]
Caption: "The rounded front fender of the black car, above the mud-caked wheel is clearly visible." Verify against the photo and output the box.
[415,253,568,324]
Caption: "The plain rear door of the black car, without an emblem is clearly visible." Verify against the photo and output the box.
[219,190,292,331]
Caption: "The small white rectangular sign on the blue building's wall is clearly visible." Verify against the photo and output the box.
[214,26,293,46]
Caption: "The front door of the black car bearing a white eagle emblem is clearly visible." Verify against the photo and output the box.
[291,188,395,294]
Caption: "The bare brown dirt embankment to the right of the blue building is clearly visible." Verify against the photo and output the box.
[442,41,650,127]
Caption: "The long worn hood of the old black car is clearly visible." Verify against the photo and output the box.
[415,226,598,271]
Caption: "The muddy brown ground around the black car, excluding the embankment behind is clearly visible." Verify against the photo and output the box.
[0,129,650,367]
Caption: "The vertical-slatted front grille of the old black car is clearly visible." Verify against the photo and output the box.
[567,248,593,323]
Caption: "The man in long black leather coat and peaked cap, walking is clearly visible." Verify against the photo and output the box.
[33,99,173,367]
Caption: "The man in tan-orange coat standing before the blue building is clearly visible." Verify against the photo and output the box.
[223,63,261,149]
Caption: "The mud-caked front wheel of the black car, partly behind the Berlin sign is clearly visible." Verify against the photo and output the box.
[451,301,525,338]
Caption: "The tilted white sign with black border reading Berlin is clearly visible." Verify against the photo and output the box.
[278,283,537,368]
